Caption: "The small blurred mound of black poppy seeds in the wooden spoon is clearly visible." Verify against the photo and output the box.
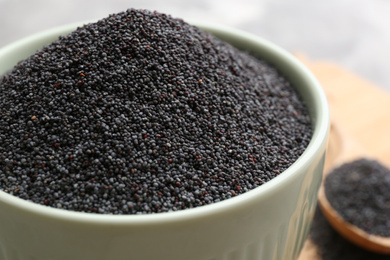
[325,159,390,237]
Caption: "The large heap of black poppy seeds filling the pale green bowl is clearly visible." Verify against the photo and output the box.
[0,9,312,214]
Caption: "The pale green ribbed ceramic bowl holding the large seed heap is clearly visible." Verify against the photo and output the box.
[0,23,329,260]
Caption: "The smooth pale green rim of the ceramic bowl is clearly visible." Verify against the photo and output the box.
[0,21,330,226]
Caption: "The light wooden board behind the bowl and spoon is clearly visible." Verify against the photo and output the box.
[298,55,390,260]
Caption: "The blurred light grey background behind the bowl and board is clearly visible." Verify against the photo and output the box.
[0,0,390,91]
